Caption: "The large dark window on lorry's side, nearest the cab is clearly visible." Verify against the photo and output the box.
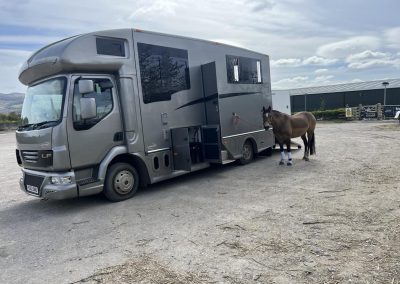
[138,43,190,104]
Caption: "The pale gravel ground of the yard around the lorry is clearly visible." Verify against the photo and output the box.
[0,121,400,284]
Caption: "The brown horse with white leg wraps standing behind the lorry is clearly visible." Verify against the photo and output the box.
[262,107,317,166]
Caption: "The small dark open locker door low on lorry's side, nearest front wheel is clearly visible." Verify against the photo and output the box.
[171,127,191,172]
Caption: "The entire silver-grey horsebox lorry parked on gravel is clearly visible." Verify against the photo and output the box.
[16,29,275,201]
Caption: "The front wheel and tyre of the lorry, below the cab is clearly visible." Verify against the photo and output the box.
[104,163,139,202]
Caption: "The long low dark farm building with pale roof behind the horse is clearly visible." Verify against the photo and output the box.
[272,79,400,113]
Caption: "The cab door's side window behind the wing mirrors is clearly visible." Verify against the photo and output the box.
[72,79,113,130]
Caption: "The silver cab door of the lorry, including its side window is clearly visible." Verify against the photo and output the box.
[67,76,123,169]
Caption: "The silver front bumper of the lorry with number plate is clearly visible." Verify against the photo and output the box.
[19,169,78,200]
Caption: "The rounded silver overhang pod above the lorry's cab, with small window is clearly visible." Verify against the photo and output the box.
[19,29,134,85]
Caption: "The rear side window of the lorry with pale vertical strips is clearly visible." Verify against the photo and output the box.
[226,55,262,84]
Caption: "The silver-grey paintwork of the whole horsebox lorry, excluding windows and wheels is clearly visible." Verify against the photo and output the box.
[17,29,274,199]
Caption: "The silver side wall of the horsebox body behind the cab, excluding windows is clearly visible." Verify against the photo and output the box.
[133,30,274,163]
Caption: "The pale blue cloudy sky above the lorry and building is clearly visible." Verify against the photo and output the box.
[0,0,400,93]
